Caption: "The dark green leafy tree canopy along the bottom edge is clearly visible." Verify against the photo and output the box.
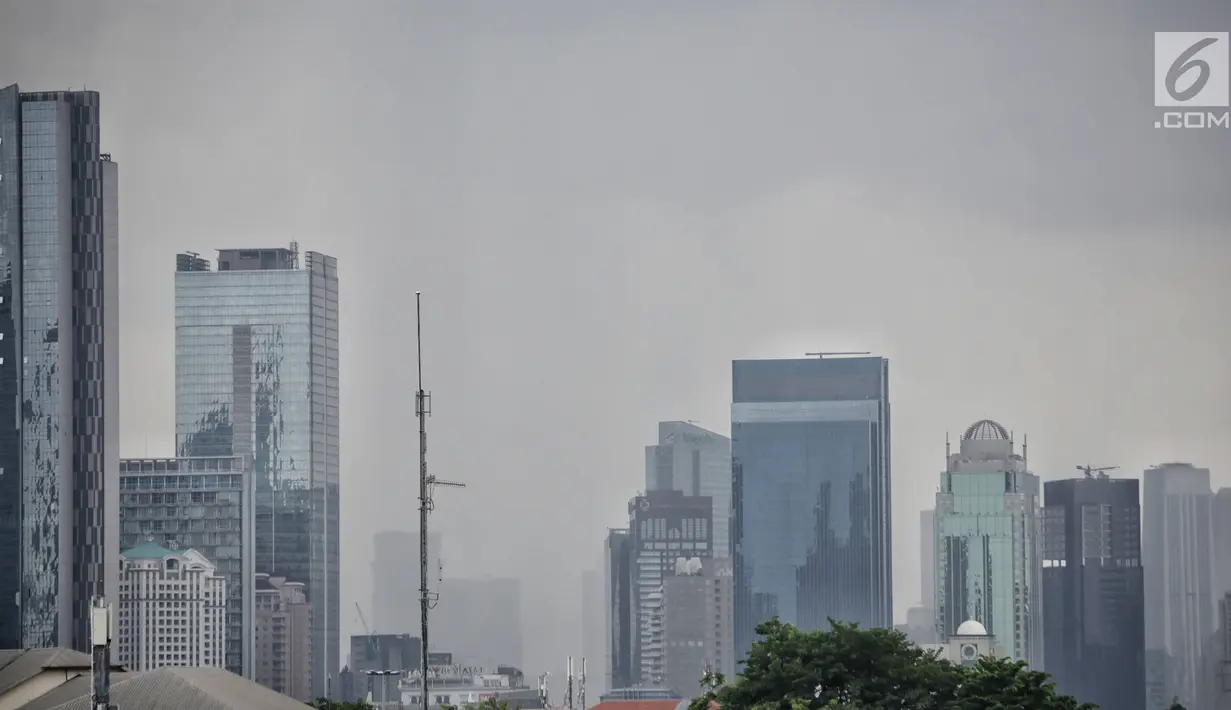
[689,619,1094,710]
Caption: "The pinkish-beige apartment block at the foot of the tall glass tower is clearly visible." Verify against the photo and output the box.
[255,575,314,703]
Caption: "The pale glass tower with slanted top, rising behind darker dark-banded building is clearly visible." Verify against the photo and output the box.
[645,422,731,557]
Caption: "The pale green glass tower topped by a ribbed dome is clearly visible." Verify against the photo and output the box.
[936,420,1044,669]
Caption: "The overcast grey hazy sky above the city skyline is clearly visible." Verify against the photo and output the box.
[0,0,1231,674]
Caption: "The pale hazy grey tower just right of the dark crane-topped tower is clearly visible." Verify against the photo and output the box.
[1141,463,1215,710]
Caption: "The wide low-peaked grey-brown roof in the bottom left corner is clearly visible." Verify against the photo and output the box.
[20,667,305,710]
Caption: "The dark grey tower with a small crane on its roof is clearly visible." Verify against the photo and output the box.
[1043,475,1146,710]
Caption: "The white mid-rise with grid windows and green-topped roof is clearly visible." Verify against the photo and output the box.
[117,541,227,672]
